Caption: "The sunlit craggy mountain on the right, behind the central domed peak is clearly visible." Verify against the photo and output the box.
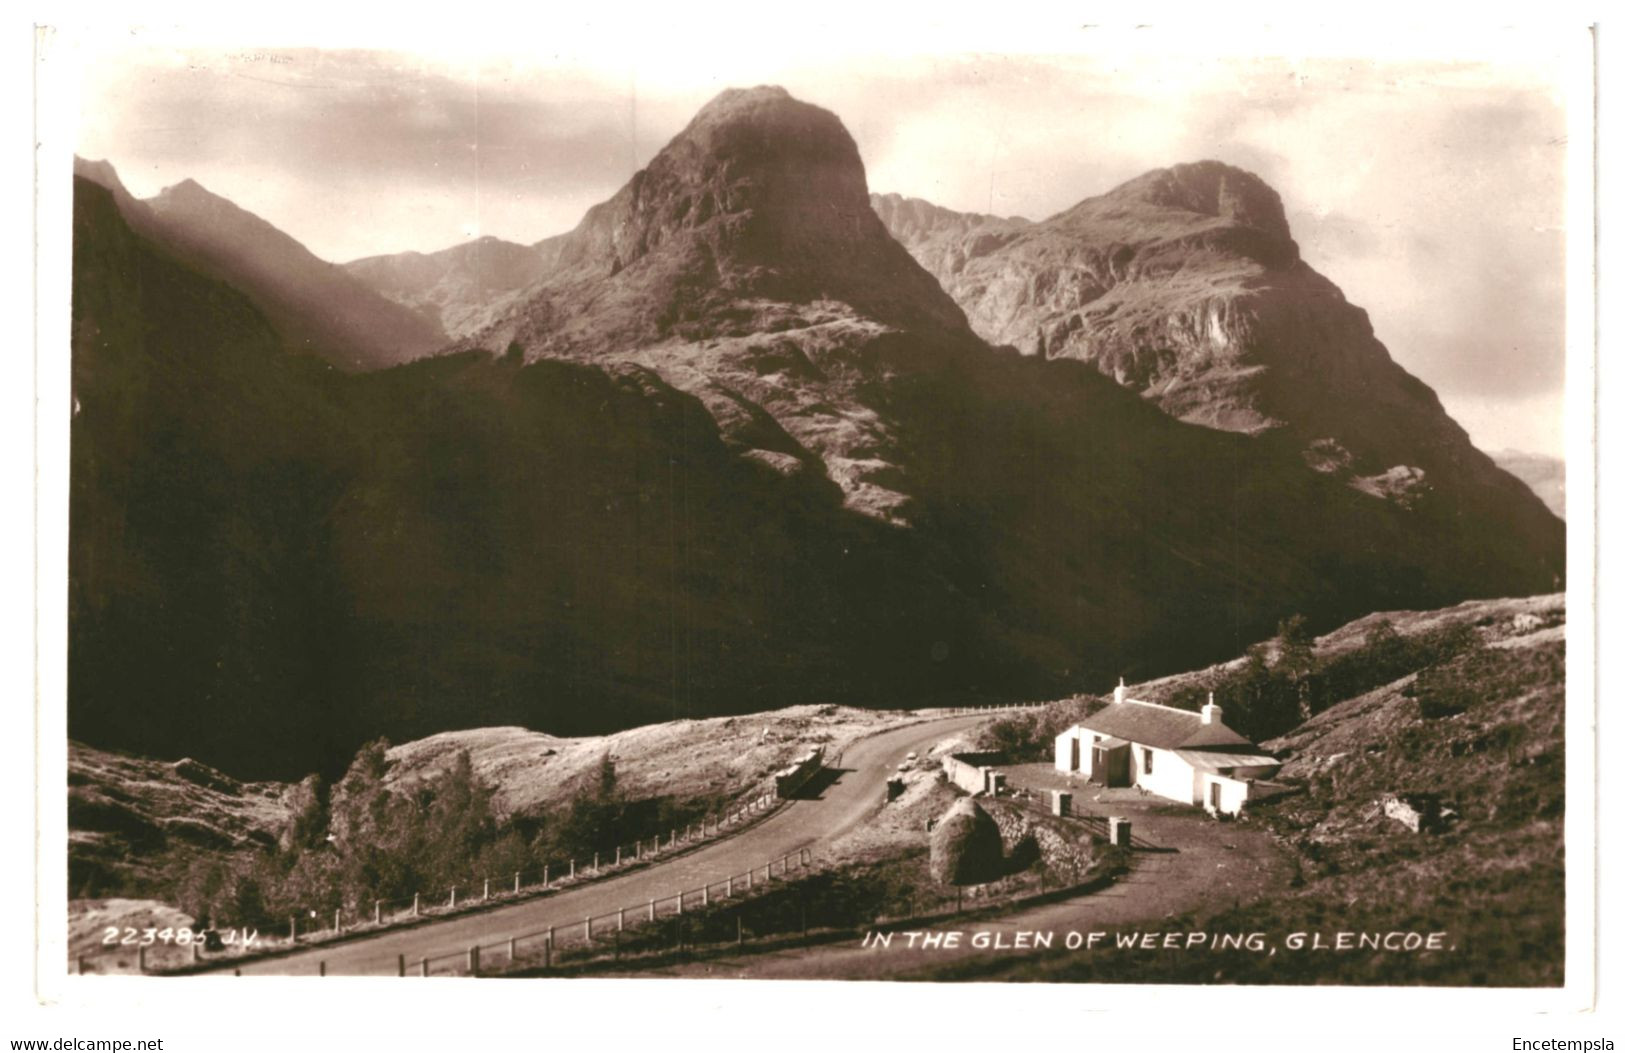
[876,169,1537,522]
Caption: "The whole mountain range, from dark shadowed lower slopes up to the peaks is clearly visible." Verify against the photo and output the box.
[68,88,1563,777]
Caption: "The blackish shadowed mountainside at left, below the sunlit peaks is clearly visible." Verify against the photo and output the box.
[70,182,941,777]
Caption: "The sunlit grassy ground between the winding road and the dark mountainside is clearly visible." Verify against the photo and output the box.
[68,705,913,913]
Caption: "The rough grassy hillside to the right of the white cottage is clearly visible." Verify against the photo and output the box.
[916,603,1565,986]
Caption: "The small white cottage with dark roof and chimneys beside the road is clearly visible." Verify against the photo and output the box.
[1055,681,1281,816]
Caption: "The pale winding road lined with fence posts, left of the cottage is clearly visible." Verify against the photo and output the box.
[209,713,986,977]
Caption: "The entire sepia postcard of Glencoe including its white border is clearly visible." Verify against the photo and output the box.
[19,12,1596,1040]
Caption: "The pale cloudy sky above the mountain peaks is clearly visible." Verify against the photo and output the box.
[63,34,1568,455]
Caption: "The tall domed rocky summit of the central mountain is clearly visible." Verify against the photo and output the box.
[484,86,969,353]
